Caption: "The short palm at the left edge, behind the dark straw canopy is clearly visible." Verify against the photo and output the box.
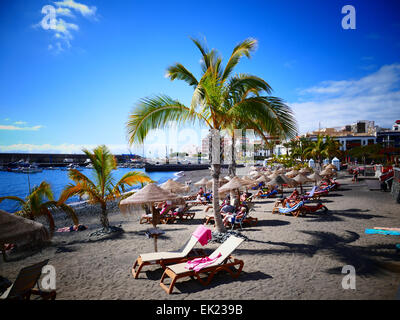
[0,181,79,234]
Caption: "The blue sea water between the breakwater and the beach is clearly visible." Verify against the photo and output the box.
[0,168,177,212]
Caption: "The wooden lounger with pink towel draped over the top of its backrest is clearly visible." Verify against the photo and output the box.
[132,236,205,279]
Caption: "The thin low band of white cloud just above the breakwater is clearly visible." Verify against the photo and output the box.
[0,143,128,154]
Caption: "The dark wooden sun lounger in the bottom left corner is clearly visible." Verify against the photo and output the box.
[2,260,56,300]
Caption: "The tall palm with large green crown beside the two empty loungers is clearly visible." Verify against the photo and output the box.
[127,39,296,232]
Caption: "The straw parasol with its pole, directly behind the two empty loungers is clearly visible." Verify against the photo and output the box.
[119,183,181,252]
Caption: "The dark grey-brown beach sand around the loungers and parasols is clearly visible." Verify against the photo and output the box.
[0,168,400,300]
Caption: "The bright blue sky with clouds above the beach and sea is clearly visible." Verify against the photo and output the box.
[0,0,400,153]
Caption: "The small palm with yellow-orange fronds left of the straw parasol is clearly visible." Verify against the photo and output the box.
[60,145,152,231]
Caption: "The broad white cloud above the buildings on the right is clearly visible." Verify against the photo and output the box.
[289,63,400,133]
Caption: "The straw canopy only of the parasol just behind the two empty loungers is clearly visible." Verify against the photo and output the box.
[119,183,181,213]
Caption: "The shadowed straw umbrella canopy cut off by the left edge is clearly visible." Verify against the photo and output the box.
[0,210,50,244]
